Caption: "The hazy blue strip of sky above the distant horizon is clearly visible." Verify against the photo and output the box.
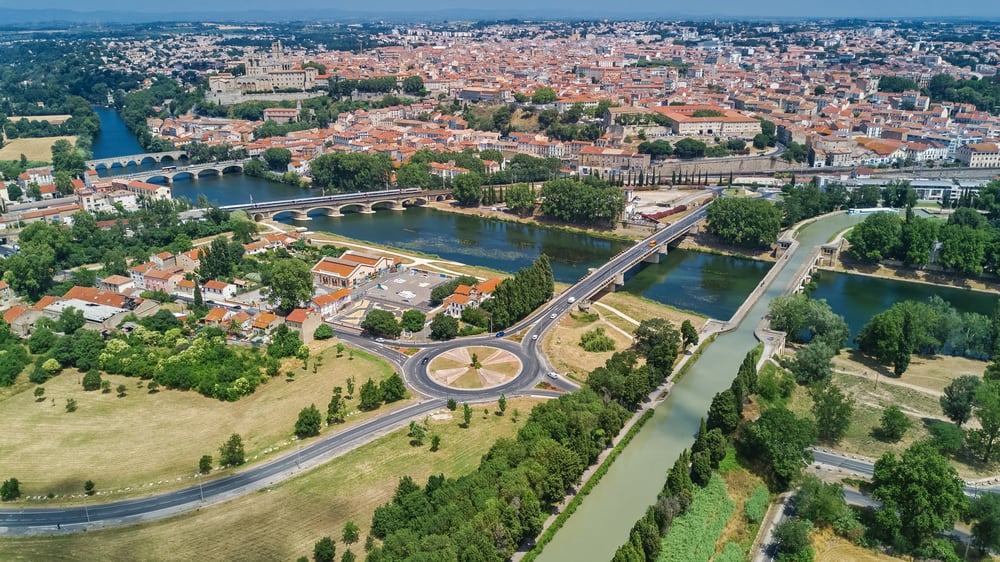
[0,0,1000,19]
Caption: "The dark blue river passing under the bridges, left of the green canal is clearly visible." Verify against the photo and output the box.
[93,107,767,318]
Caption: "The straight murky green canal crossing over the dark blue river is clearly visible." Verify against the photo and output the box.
[539,214,863,562]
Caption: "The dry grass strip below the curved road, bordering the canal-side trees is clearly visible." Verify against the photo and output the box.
[0,399,539,561]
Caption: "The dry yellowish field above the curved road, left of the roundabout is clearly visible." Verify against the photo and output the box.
[0,336,398,498]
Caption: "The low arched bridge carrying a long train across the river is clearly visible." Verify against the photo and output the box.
[222,188,452,221]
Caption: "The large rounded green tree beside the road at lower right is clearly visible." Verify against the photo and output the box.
[872,442,968,550]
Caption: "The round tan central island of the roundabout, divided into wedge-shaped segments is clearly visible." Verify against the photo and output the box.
[427,346,522,389]
